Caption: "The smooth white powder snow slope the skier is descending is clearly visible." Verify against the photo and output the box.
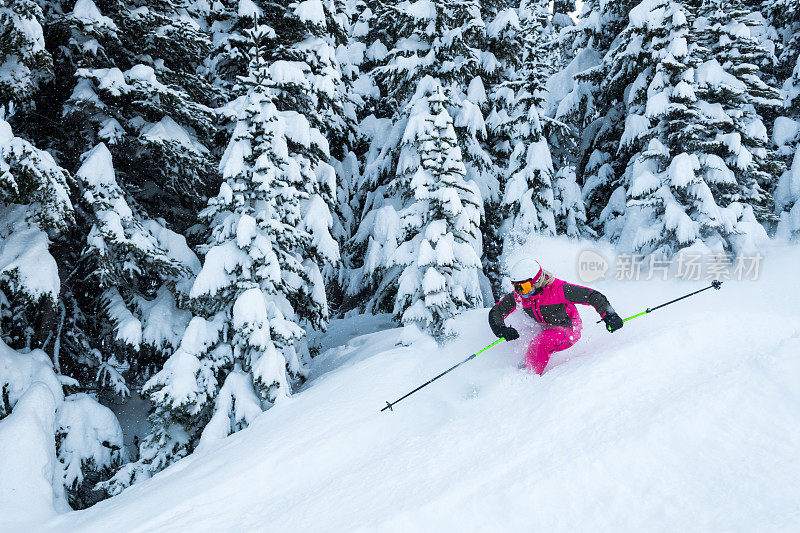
[34,242,800,531]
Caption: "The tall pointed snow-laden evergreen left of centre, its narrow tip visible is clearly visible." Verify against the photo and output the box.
[192,67,328,401]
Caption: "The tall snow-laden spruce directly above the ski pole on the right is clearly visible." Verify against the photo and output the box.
[605,0,721,255]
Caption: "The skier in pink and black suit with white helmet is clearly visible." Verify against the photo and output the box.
[489,259,622,375]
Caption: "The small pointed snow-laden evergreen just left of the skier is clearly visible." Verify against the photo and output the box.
[388,78,482,337]
